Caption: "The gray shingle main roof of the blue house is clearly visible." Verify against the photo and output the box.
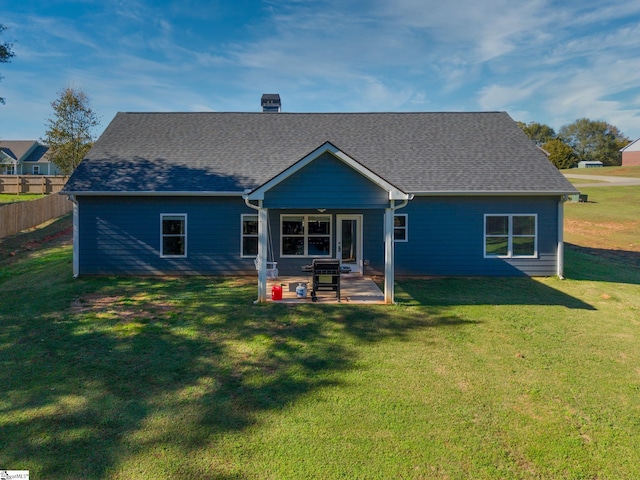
[64,112,575,193]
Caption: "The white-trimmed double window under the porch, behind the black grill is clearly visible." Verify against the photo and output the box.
[280,215,331,257]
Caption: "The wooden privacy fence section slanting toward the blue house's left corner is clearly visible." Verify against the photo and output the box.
[0,193,73,238]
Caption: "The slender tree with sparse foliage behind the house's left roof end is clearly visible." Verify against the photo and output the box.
[42,87,100,175]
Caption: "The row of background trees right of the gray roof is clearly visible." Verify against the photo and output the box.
[517,118,630,169]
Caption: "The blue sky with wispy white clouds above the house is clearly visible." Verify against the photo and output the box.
[0,0,640,140]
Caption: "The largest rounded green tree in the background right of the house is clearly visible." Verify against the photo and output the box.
[559,118,629,165]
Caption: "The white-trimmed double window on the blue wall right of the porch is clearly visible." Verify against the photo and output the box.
[484,214,538,258]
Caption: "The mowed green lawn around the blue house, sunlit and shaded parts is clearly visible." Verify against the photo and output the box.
[0,207,640,479]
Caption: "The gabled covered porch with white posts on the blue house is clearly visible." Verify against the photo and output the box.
[244,142,413,304]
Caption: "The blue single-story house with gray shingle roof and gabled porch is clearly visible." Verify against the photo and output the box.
[62,103,578,303]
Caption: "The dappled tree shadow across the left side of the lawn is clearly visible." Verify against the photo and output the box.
[0,255,476,478]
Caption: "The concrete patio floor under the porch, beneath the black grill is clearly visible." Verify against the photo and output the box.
[267,274,384,305]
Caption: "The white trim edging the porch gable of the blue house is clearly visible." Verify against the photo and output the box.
[248,142,409,200]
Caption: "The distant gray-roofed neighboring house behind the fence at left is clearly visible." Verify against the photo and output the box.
[0,140,61,175]
